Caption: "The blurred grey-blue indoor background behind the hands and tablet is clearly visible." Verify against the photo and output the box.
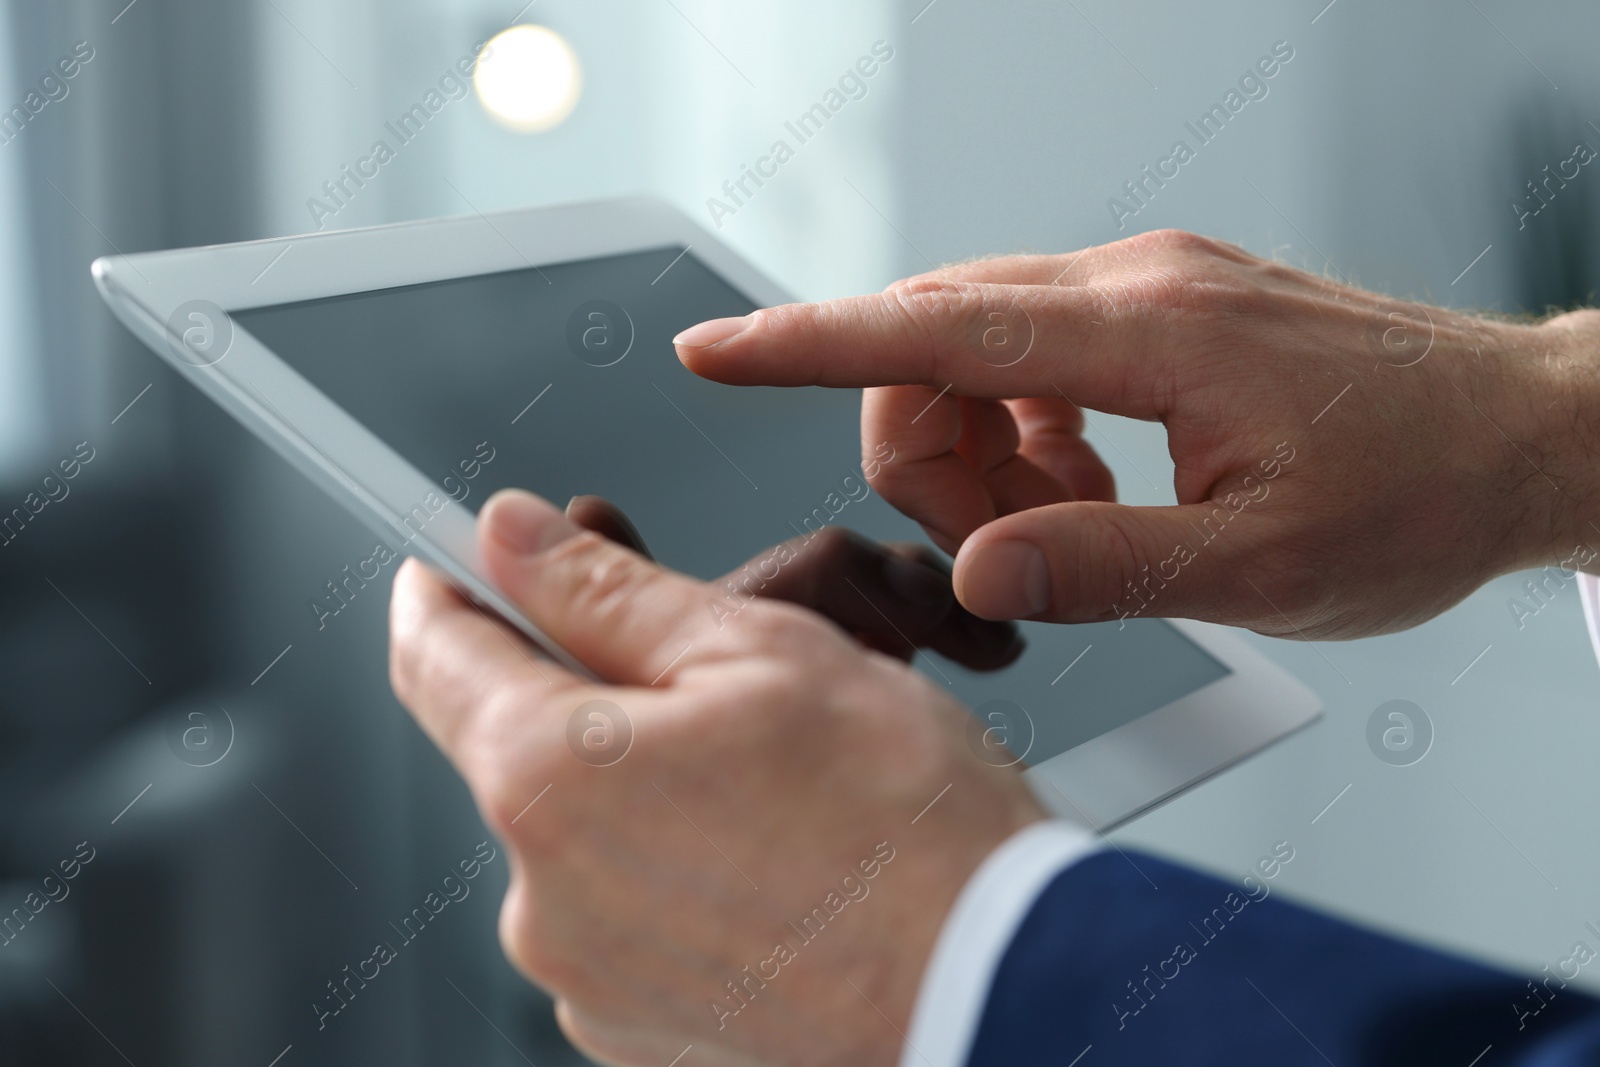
[0,0,1600,1067]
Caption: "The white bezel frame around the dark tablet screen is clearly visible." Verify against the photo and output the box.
[93,198,1322,830]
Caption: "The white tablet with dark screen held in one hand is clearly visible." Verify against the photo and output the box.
[94,200,1318,829]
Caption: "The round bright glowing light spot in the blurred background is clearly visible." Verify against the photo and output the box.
[472,26,584,133]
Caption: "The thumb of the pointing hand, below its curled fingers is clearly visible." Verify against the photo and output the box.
[954,501,1259,622]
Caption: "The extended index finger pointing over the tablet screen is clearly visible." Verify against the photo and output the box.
[674,278,1171,419]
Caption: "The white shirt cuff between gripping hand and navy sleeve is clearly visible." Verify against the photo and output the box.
[901,821,1101,1067]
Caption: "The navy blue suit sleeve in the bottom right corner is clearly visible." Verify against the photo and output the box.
[968,851,1600,1067]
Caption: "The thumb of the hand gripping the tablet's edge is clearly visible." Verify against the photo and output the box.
[478,490,707,685]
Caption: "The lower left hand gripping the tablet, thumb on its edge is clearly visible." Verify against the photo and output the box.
[390,493,1043,1065]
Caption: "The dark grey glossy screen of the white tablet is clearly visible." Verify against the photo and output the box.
[234,248,1229,763]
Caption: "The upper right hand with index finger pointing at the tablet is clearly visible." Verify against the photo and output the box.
[677,230,1600,637]
